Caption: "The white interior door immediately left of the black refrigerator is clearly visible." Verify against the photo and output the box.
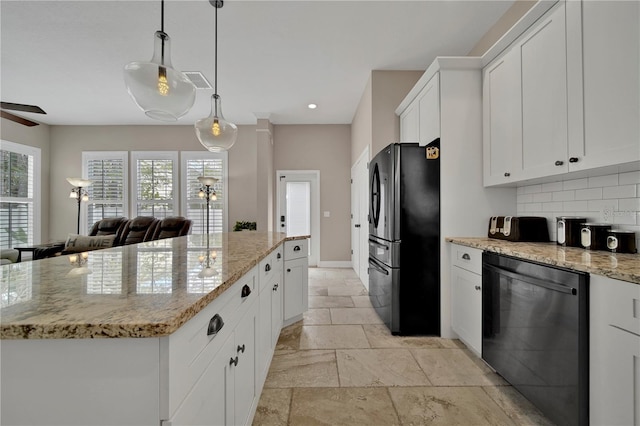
[351,147,369,290]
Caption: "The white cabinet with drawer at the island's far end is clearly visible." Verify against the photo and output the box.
[283,239,309,326]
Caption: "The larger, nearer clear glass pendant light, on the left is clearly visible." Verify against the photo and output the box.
[124,0,196,121]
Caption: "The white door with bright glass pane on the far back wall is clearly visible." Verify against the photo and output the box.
[276,170,320,266]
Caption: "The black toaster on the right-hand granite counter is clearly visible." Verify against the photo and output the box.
[488,216,549,243]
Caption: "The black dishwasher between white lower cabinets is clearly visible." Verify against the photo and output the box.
[482,252,589,425]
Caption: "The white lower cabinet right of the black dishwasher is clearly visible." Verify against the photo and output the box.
[589,275,640,426]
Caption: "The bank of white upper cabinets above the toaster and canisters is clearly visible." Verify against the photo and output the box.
[483,1,640,186]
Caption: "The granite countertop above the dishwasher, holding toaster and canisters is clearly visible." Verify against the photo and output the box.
[446,237,640,284]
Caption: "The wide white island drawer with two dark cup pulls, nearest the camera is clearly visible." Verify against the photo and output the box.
[161,268,258,413]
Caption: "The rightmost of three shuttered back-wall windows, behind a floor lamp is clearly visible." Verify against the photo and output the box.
[181,151,228,234]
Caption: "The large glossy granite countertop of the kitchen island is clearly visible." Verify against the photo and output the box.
[0,231,308,339]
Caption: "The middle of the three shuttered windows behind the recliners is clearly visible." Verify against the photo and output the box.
[131,151,178,219]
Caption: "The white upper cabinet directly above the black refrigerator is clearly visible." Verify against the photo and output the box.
[400,73,440,146]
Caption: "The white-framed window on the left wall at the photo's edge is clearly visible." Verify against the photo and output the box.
[0,141,40,248]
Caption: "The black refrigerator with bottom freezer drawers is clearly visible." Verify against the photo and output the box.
[369,139,440,336]
